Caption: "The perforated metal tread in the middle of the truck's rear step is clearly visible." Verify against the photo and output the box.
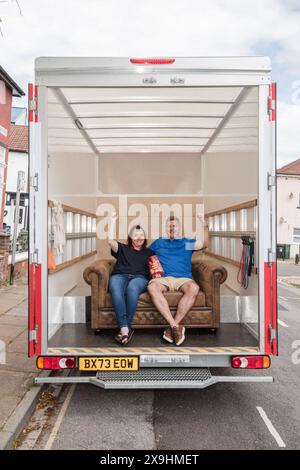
[96,367,211,383]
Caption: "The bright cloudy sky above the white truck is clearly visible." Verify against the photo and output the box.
[0,0,300,166]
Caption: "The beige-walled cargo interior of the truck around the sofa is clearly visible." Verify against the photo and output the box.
[41,77,260,354]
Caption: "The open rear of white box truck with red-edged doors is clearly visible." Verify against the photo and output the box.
[29,57,278,388]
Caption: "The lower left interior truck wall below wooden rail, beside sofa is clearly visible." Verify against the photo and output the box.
[48,255,97,339]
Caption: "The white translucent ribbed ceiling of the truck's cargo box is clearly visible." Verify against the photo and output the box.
[48,87,258,153]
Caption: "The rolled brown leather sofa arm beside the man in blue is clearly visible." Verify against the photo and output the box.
[192,258,227,307]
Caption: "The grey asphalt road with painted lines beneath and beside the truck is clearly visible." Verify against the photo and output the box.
[15,286,300,450]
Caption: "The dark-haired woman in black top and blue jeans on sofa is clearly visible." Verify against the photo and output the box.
[108,215,154,346]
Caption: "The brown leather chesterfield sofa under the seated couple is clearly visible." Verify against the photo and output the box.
[83,258,227,331]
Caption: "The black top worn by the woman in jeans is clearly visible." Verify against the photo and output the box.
[111,242,154,279]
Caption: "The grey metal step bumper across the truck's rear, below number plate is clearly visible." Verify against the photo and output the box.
[34,368,274,389]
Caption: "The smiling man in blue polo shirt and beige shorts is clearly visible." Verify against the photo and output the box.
[148,216,208,346]
